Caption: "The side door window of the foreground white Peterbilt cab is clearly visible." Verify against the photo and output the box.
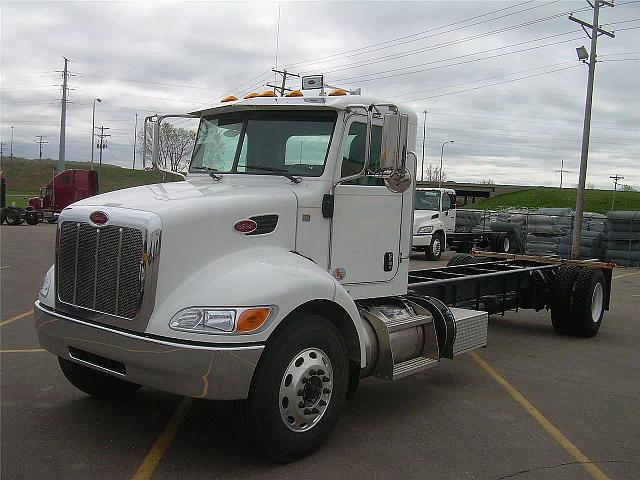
[340,122,384,185]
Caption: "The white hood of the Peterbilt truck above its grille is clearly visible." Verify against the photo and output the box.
[60,181,298,308]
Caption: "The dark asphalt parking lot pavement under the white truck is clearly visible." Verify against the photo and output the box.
[0,224,640,480]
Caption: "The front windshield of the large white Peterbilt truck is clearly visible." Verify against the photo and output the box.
[189,111,338,177]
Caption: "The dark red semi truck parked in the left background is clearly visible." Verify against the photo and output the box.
[2,169,98,225]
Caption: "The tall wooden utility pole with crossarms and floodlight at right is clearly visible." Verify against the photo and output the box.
[569,0,615,260]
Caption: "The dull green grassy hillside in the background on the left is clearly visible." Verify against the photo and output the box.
[2,158,180,196]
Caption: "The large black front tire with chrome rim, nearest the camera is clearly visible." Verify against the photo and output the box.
[236,313,349,463]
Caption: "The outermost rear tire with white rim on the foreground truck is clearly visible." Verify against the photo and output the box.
[572,268,606,338]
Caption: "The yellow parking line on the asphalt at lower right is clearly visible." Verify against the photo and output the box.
[470,352,609,480]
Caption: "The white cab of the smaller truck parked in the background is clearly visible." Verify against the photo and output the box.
[412,187,456,260]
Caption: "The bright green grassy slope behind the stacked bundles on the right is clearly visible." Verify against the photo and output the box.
[473,187,640,213]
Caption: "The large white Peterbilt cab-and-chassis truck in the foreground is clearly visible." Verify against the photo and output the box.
[35,89,611,462]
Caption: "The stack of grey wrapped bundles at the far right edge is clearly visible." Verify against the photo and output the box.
[606,211,640,267]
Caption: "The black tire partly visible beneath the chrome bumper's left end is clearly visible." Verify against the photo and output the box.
[58,357,140,400]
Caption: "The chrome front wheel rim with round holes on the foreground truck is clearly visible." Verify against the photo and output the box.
[278,348,333,432]
